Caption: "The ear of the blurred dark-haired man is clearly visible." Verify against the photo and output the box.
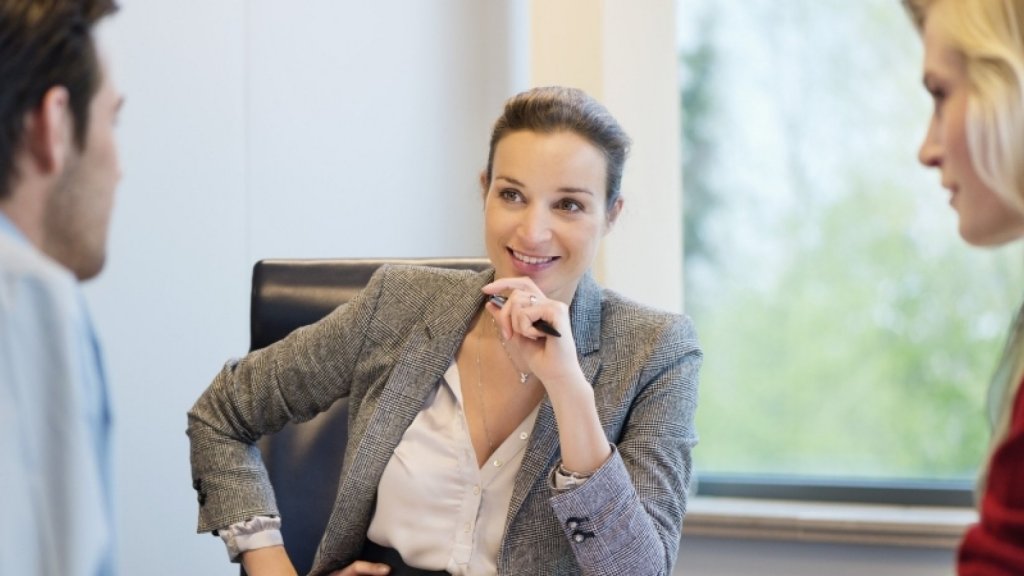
[25,86,75,174]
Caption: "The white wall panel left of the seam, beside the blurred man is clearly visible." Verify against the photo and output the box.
[87,0,249,575]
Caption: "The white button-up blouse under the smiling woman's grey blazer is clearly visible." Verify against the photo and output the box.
[367,363,540,576]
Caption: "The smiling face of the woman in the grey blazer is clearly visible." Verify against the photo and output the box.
[483,131,622,303]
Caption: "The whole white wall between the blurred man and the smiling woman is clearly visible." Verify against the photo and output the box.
[86,0,514,575]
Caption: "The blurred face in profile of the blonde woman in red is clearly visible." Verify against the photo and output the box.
[919,18,1024,246]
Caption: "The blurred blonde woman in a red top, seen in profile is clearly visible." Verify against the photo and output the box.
[904,0,1024,575]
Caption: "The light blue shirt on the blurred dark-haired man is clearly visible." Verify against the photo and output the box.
[0,213,116,576]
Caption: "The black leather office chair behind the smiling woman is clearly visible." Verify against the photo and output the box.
[242,258,490,575]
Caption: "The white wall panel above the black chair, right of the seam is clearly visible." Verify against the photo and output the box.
[245,0,516,259]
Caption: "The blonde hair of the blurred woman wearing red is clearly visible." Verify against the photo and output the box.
[903,0,1024,494]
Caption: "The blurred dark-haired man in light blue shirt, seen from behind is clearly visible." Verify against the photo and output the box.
[0,0,122,576]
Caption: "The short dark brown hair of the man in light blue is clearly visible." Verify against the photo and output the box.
[0,0,118,200]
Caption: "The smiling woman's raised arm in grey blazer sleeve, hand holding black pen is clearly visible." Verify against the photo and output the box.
[483,278,702,576]
